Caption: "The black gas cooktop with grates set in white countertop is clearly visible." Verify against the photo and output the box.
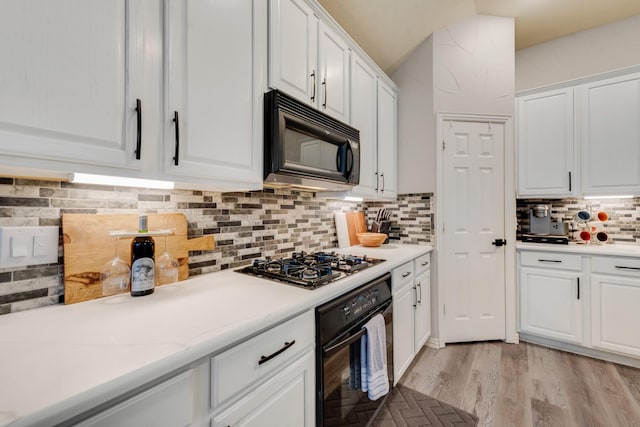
[236,251,384,289]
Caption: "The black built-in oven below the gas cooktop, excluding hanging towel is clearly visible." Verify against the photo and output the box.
[316,273,393,427]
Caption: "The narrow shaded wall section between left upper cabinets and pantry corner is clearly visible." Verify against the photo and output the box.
[391,36,436,194]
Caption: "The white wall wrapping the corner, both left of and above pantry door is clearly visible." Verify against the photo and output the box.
[391,16,515,194]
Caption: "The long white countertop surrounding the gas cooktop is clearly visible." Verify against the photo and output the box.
[0,244,433,427]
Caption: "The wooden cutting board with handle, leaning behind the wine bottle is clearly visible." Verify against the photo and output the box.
[62,213,215,304]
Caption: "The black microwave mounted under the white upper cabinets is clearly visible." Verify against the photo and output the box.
[264,90,360,191]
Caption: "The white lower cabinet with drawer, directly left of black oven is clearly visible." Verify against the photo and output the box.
[210,310,315,427]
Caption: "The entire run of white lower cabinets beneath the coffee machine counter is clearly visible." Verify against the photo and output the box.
[518,250,640,366]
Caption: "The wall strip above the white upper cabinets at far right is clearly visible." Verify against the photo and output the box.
[515,15,640,92]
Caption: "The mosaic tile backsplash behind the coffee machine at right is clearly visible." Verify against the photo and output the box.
[516,197,640,244]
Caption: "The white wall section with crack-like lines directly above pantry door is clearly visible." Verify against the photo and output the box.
[433,16,515,116]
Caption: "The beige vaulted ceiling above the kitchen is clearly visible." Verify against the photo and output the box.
[319,0,640,73]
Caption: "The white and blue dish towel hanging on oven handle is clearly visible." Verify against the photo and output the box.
[360,314,389,400]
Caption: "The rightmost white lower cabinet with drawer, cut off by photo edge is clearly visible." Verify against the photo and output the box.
[591,257,640,357]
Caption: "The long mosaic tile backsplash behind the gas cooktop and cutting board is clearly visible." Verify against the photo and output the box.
[0,177,433,314]
